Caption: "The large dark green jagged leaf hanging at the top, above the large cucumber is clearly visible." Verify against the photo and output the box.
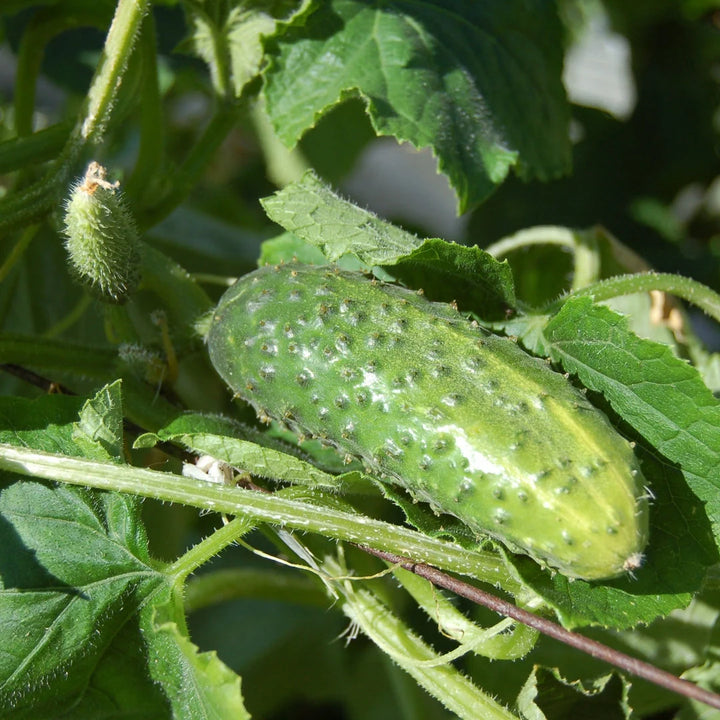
[265,0,570,212]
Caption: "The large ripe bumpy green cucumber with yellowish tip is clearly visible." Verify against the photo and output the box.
[208,264,648,580]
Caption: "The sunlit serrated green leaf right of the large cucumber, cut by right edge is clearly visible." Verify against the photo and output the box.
[544,298,720,542]
